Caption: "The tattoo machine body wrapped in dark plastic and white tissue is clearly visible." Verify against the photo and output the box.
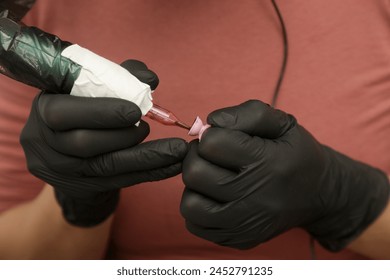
[0,13,153,115]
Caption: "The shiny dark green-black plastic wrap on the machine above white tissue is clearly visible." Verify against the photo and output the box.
[0,12,81,93]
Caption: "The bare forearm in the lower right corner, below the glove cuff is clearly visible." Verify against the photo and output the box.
[349,176,390,260]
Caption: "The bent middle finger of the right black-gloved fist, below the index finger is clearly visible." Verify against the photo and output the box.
[182,139,248,202]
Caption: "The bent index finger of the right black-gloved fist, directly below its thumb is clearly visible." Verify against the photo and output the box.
[198,127,268,172]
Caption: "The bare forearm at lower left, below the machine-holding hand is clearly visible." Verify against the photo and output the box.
[0,186,112,259]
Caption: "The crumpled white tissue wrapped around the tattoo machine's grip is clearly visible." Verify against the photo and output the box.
[61,45,153,115]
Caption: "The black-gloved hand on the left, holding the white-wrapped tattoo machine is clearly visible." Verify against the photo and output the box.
[21,61,187,226]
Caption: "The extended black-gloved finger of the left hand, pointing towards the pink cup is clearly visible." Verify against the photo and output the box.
[79,138,187,177]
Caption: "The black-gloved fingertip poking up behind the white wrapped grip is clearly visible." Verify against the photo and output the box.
[121,59,159,90]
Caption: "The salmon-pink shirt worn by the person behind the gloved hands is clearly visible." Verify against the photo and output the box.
[0,0,390,259]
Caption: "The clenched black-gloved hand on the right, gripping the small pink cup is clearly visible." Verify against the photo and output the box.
[181,100,390,251]
